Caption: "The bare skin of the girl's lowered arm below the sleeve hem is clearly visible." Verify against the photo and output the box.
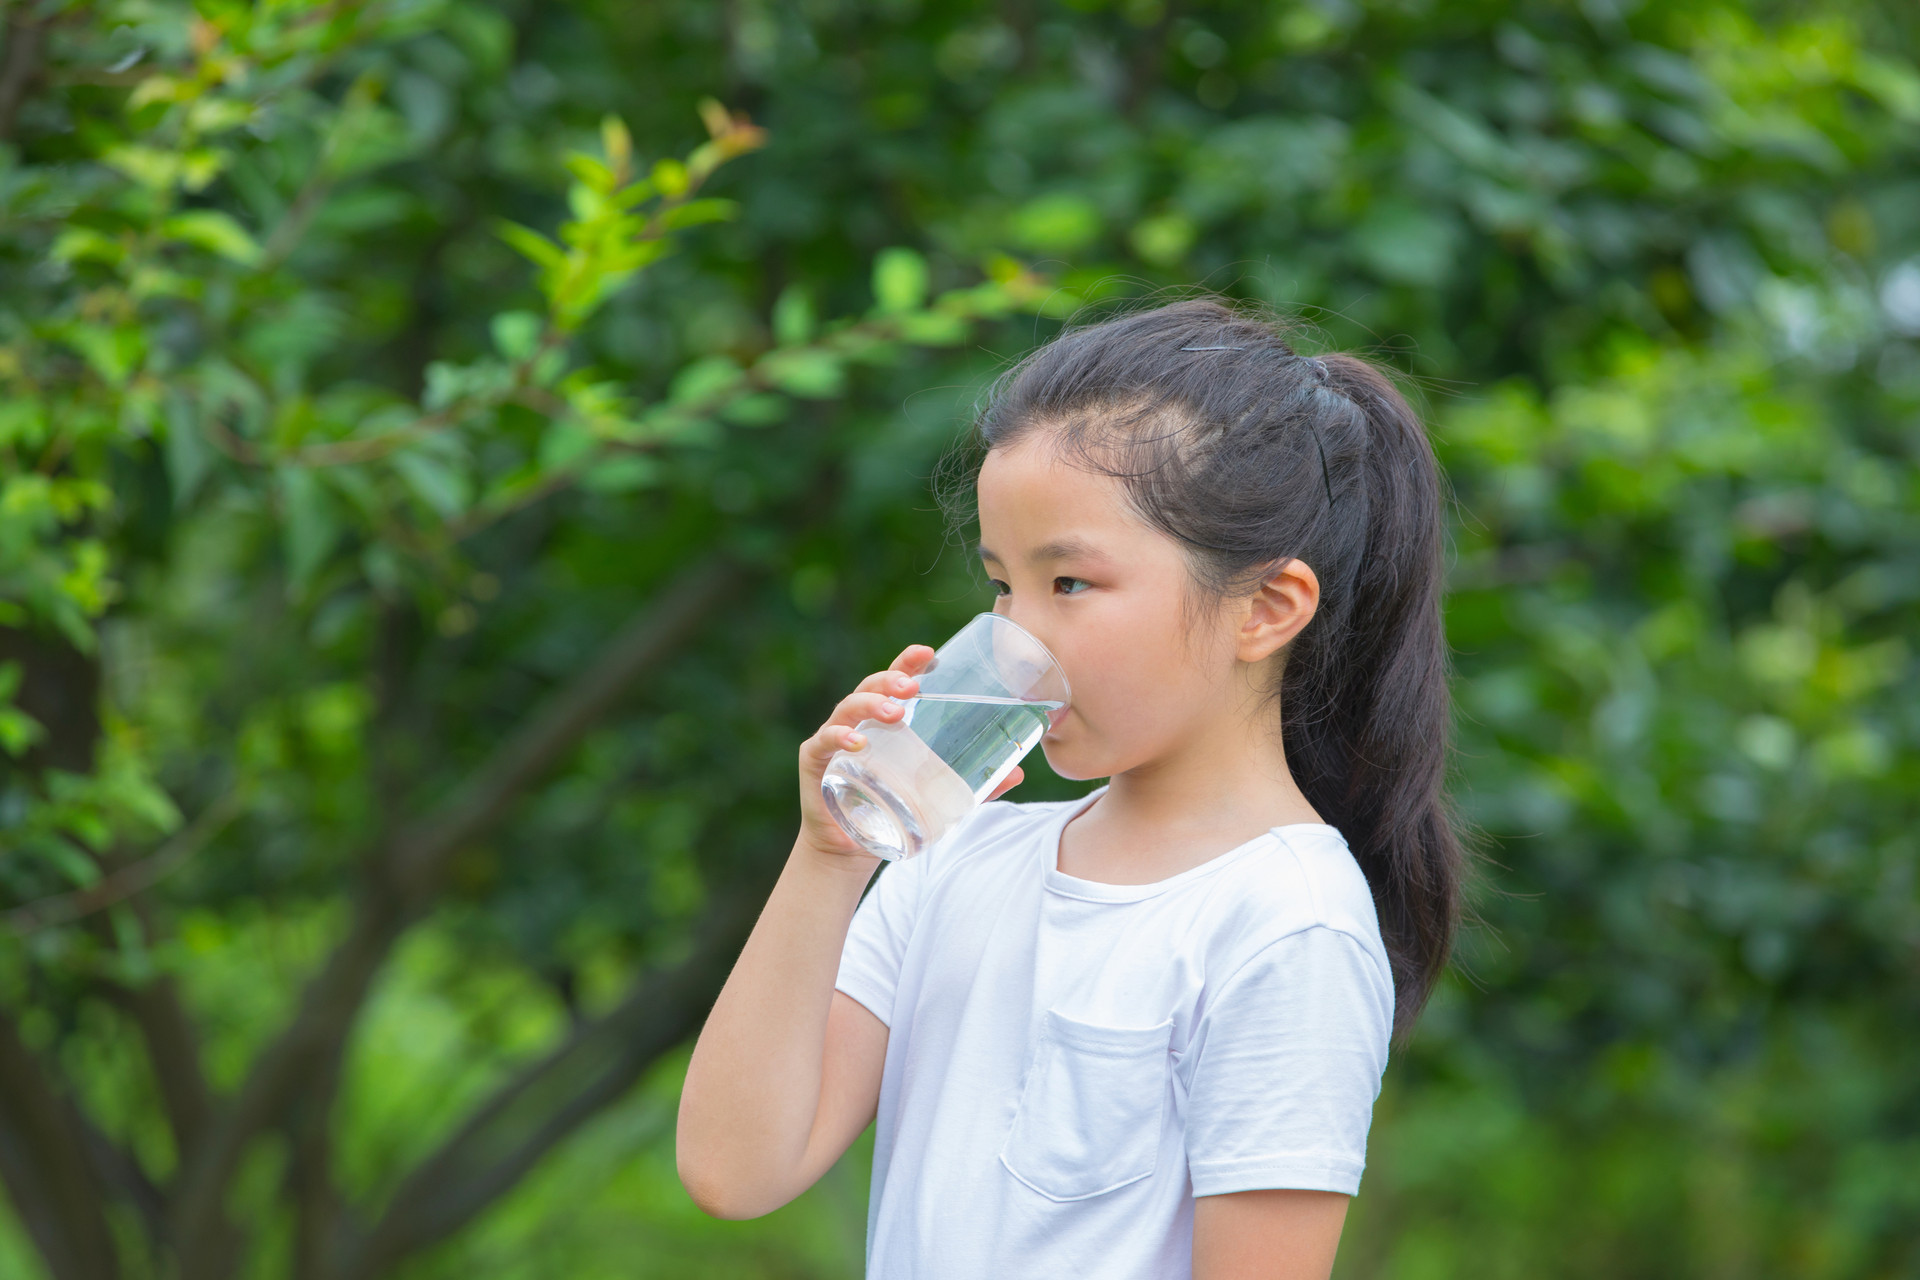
[1194,1190,1350,1280]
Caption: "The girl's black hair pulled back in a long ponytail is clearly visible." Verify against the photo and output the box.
[939,297,1465,1040]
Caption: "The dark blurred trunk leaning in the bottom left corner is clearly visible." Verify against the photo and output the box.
[0,1013,119,1280]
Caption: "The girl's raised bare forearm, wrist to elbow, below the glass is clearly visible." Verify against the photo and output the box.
[678,839,877,1217]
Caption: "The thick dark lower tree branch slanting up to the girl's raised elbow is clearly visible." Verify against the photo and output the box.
[334,885,758,1280]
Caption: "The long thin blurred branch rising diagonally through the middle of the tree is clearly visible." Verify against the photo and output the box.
[175,555,743,1276]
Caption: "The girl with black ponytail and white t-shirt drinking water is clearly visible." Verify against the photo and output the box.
[678,299,1461,1280]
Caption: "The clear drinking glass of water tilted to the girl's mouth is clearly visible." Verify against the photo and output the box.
[820,614,1071,862]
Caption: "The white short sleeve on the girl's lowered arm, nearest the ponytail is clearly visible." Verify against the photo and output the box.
[1183,925,1394,1196]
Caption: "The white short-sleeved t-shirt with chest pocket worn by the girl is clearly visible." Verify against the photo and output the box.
[837,787,1394,1280]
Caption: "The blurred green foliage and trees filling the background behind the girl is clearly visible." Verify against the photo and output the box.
[0,0,1920,1280]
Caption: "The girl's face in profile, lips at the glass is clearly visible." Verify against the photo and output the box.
[977,432,1250,779]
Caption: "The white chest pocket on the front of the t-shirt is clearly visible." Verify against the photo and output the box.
[1000,1009,1173,1199]
